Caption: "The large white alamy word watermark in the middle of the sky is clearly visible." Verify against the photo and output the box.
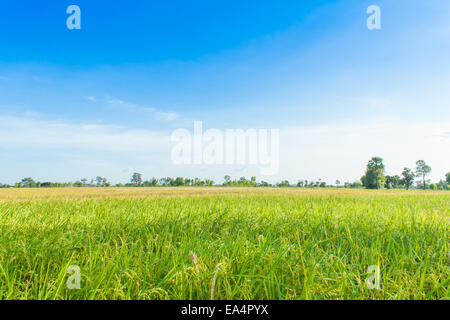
[171,121,280,176]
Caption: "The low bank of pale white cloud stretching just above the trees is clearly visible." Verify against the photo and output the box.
[0,116,450,183]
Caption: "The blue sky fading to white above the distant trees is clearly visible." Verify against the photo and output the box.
[0,0,450,183]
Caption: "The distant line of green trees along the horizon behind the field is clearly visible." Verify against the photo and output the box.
[0,157,450,190]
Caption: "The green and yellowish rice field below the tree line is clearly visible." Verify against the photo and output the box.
[0,188,450,299]
